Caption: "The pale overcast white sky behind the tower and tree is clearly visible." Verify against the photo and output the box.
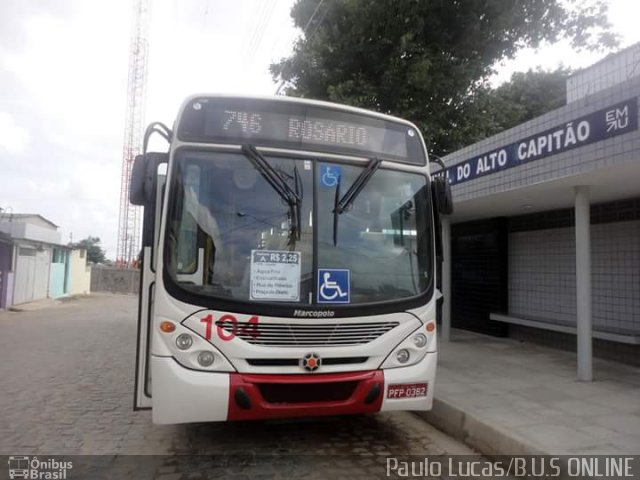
[0,0,640,259]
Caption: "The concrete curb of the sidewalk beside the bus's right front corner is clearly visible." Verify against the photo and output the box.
[414,398,548,456]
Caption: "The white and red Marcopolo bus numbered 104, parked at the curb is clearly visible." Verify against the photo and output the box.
[130,95,452,424]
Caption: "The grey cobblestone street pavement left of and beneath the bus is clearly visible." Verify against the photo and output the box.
[0,295,480,480]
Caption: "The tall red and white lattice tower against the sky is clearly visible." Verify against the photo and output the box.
[116,0,149,266]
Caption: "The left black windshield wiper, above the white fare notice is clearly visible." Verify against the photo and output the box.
[241,145,302,243]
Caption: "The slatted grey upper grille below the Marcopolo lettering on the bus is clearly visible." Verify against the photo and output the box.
[216,321,399,347]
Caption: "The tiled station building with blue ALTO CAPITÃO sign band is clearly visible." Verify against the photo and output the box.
[439,44,640,374]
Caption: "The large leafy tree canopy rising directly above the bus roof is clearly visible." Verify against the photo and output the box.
[271,0,617,153]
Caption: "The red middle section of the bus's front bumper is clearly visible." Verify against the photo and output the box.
[228,370,384,420]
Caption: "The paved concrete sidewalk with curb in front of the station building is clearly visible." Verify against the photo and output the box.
[422,330,640,455]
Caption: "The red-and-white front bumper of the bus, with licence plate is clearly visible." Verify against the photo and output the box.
[151,353,437,424]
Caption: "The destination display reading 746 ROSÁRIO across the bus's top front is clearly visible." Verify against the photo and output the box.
[178,98,426,165]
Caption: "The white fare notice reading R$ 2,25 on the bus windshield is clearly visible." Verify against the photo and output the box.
[250,250,301,302]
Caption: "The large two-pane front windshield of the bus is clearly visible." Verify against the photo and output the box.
[165,150,433,306]
